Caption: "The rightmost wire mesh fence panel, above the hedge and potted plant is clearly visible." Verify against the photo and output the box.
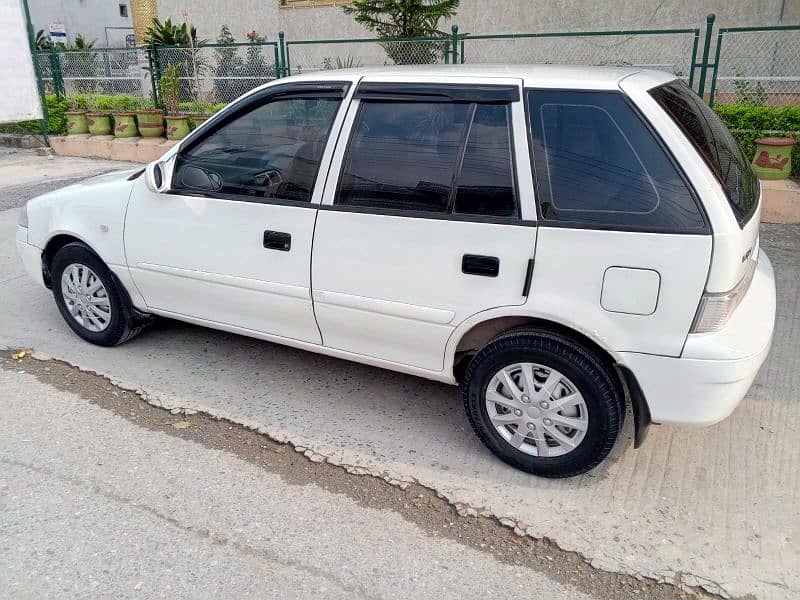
[711,25,800,106]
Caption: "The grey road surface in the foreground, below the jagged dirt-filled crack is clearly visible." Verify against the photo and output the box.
[0,363,600,600]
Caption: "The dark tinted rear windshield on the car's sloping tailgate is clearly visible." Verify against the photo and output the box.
[650,81,759,227]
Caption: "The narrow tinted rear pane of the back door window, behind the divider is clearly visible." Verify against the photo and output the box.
[454,104,517,217]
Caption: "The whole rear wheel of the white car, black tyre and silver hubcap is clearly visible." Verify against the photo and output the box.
[463,330,625,478]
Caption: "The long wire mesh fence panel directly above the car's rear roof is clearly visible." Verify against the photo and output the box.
[461,29,700,79]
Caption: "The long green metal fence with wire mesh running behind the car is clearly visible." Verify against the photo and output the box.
[17,15,800,142]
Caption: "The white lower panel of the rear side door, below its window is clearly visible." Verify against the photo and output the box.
[312,210,536,370]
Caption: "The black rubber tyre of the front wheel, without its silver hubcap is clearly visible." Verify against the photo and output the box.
[50,242,144,346]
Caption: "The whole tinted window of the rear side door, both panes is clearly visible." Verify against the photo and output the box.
[335,101,518,216]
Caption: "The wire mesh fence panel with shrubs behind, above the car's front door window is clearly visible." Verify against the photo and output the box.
[156,42,280,103]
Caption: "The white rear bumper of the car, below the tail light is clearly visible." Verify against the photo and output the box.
[621,252,775,426]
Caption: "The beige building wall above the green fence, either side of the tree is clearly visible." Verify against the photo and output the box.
[156,0,800,41]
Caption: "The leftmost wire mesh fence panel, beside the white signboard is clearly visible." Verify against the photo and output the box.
[36,48,152,98]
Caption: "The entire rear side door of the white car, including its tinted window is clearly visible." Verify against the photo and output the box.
[312,75,536,371]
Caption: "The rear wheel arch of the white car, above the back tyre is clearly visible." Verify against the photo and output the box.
[445,311,650,448]
